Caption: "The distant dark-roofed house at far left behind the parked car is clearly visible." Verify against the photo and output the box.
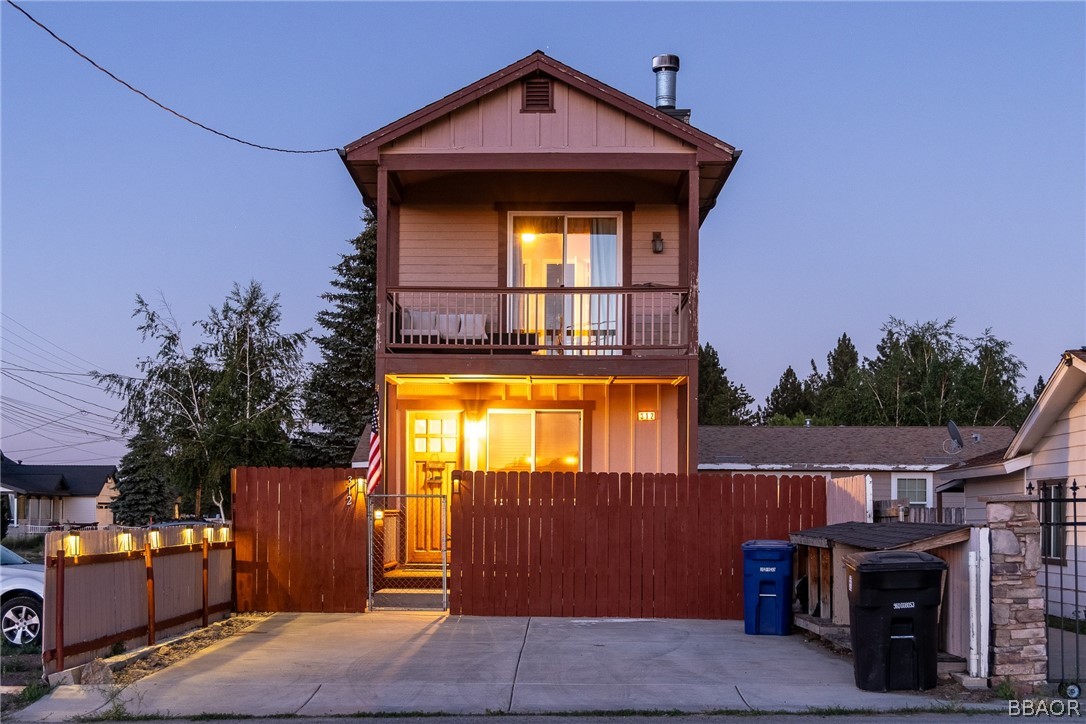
[0,454,117,526]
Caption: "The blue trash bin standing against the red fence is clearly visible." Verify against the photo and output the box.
[743,541,795,636]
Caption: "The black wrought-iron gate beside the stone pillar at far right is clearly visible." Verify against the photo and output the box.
[1028,480,1086,699]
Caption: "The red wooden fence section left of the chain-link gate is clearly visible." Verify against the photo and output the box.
[230,468,369,612]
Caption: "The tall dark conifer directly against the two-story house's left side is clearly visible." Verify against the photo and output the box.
[298,213,377,466]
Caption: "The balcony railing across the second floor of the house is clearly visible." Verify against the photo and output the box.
[384,287,690,355]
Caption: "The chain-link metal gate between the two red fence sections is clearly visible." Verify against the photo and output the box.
[366,495,449,611]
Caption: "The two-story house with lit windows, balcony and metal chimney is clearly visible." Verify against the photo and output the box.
[343,51,740,560]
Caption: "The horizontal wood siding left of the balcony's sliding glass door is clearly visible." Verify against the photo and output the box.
[393,205,498,289]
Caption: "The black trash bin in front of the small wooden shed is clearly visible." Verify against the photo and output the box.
[845,550,947,691]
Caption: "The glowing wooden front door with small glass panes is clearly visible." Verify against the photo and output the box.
[407,411,460,563]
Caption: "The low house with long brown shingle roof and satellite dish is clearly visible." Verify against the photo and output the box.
[697,425,1014,519]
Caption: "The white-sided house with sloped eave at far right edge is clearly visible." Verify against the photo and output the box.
[936,350,1086,619]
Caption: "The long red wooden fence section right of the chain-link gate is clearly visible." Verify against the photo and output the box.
[447,472,825,619]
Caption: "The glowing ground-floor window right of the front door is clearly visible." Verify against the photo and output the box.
[487,410,581,472]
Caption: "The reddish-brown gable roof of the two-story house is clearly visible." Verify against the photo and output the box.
[341,50,742,220]
